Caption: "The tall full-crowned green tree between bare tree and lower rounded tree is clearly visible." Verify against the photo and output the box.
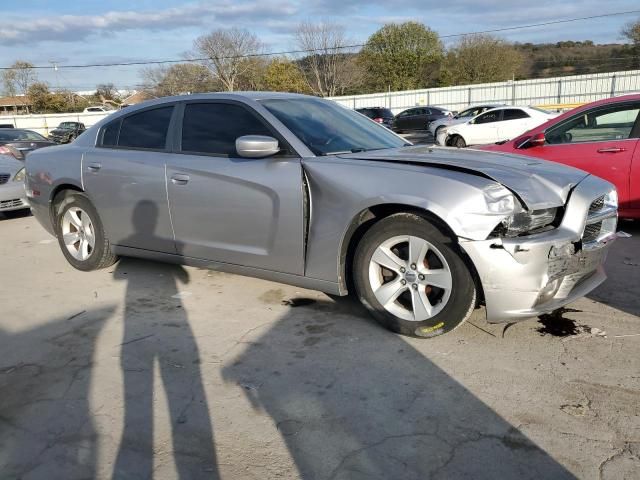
[360,22,444,91]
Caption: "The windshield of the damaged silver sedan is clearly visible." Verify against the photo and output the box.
[260,98,410,155]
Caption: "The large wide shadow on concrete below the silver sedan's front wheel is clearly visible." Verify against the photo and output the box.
[223,299,574,480]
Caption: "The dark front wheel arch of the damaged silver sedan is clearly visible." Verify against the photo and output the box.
[339,203,484,301]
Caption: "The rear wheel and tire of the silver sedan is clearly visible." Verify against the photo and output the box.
[55,192,118,272]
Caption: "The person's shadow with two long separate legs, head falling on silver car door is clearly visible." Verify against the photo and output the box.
[113,201,219,479]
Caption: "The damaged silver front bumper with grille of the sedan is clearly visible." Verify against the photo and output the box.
[460,176,617,322]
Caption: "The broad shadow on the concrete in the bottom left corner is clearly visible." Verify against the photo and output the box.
[0,306,115,479]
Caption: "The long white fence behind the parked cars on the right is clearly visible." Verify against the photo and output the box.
[331,70,640,113]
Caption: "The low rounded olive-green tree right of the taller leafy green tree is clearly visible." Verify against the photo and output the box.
[441,35,523,85]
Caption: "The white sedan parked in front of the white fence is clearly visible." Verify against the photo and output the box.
[436,107,558,147]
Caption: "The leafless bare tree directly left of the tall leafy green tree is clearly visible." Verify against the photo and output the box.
[295,22,361,97]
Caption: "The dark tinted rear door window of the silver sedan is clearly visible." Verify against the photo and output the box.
[100,106,173,150]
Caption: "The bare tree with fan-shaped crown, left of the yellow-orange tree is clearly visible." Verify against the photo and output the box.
[192,28,263,91]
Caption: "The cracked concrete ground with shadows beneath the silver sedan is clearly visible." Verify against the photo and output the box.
[0,217,640,480]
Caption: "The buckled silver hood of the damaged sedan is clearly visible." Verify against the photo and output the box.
[340,145,589,210]
